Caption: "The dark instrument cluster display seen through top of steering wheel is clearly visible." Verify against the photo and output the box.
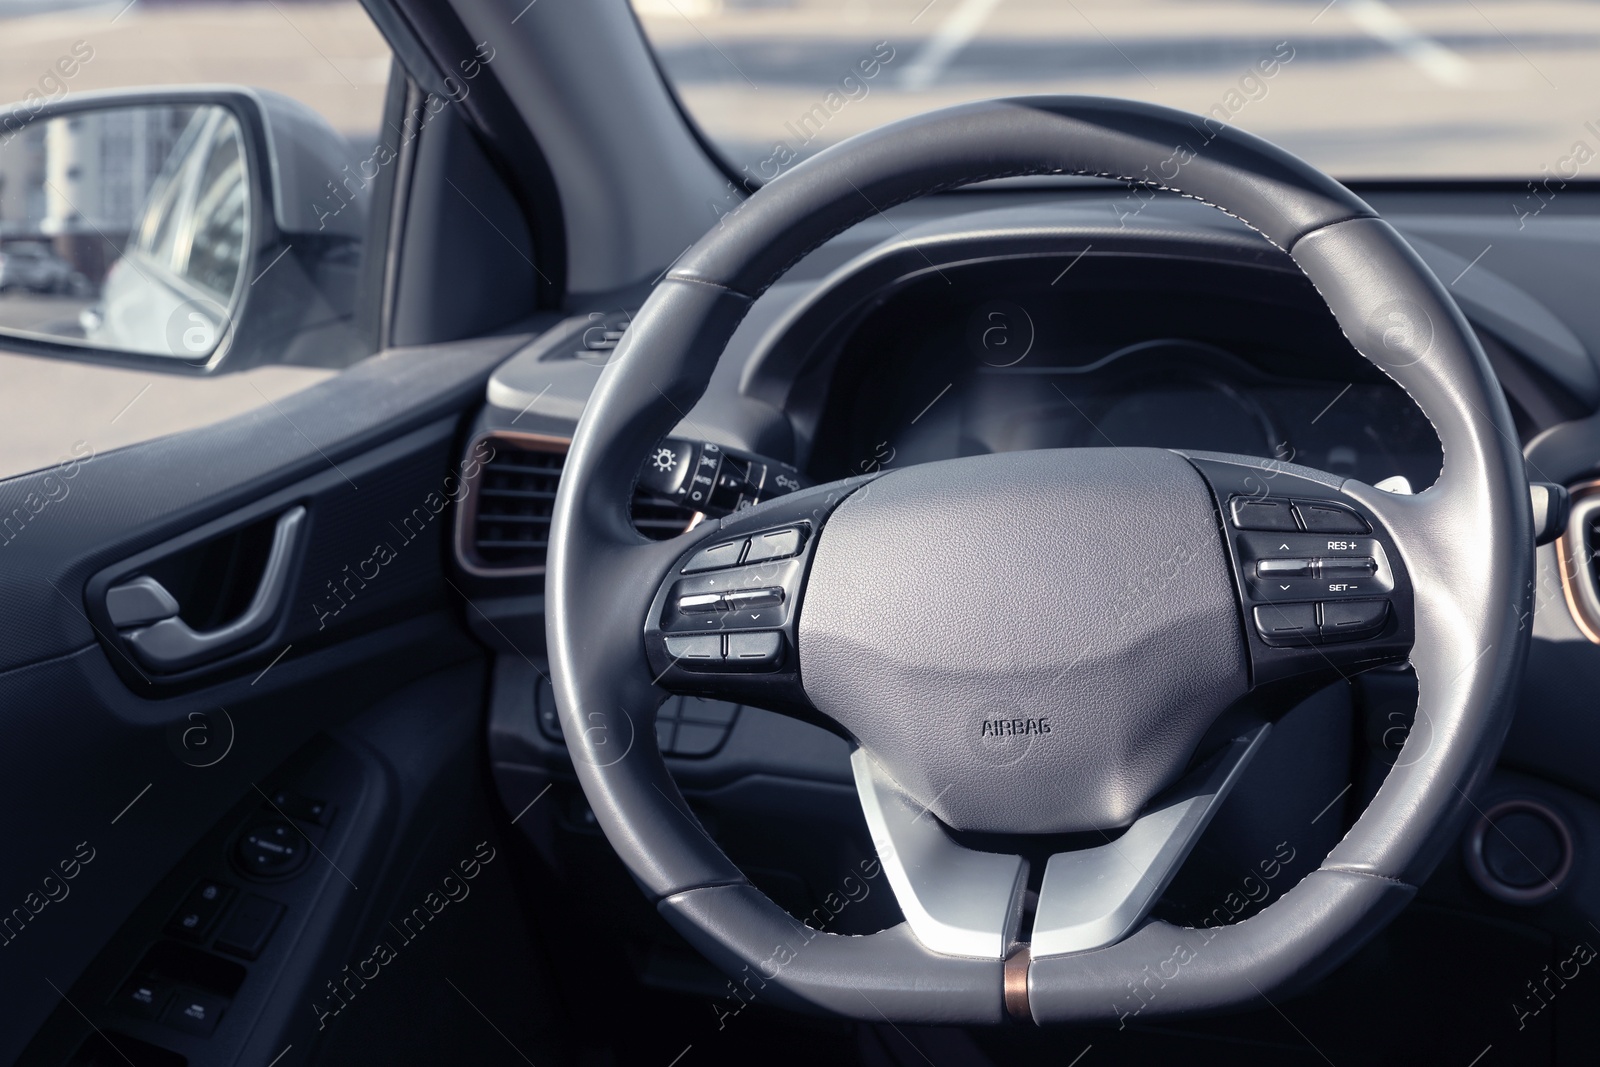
[810,251,1442,490]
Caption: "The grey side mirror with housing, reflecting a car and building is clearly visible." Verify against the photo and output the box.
[0,88,373,373]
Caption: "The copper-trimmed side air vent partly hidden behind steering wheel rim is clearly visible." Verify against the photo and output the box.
[456,434,696,577]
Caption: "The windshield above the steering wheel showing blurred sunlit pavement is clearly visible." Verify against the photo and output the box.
[634,0,1600,183]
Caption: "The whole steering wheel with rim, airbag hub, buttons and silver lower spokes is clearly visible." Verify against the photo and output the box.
[546,96,1533,1025]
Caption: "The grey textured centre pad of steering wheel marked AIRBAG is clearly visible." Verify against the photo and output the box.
[798,448,1248,833]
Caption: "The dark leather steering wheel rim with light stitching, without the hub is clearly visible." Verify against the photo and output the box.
[546,96,1533,1024]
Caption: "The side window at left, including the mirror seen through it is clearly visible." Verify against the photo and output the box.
[0,0,393,478]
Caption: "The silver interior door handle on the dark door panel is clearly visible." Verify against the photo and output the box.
[106,506,306,672]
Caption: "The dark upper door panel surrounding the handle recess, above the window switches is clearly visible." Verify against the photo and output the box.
[0,338,520,1062]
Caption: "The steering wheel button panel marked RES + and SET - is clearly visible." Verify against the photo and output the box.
[1190,456,1414,685]
